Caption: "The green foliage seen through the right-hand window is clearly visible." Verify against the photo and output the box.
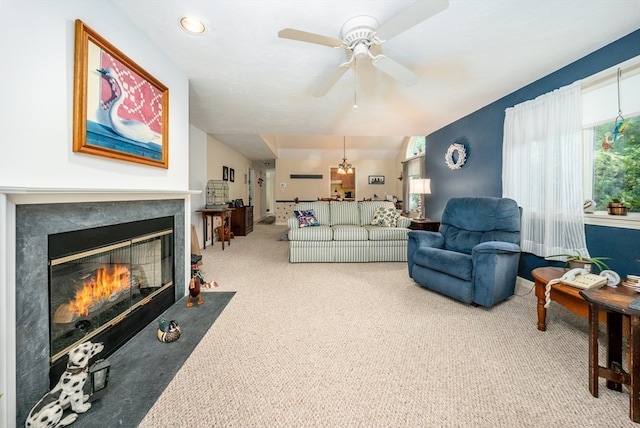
[593,116,640,212]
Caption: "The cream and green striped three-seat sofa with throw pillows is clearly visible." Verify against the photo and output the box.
[287,201,411,263]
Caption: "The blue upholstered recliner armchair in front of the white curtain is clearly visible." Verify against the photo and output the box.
[407,197,520,307]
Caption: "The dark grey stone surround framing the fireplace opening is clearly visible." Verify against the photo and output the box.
[16,199,186,424]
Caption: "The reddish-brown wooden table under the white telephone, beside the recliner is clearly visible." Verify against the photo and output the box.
[531,267,606,331]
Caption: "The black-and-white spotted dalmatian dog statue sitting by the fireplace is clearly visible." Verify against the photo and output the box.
[25,342,104,428]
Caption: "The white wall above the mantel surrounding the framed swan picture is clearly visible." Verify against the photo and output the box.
[0,0,189,190]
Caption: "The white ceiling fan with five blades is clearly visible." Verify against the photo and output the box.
[278,0,449,97]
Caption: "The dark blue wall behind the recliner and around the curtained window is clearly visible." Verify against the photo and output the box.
[425,30,640,280]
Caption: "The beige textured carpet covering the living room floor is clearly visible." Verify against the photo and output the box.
[139,224,638,428]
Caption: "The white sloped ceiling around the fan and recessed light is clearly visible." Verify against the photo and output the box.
[111,0,640,160]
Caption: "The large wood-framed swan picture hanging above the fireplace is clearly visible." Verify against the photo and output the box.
[73,19,169,168]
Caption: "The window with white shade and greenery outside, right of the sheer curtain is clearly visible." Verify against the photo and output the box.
[582,57,640,217]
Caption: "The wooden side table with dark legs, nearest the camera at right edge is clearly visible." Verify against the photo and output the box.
[580,286,640,423]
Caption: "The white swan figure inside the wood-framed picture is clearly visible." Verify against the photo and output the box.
[97,67,161,143]
